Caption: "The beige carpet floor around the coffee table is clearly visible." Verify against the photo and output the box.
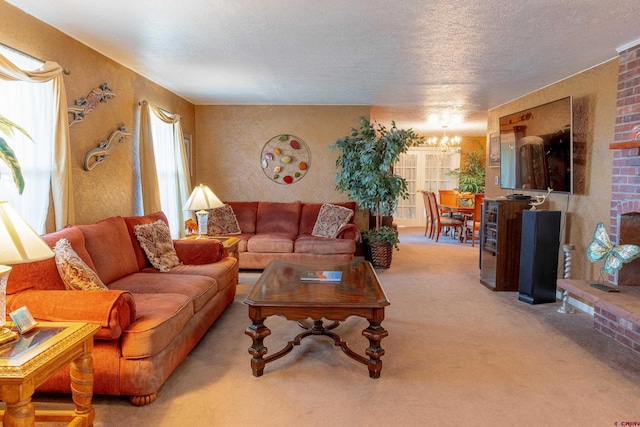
[36,229,640,427]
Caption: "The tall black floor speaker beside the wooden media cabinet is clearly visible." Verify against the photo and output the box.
[518,210,560,304]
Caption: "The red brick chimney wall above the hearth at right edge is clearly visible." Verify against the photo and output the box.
[610,45,640,247]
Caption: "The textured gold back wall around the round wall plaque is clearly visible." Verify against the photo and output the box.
[194,105,369,202]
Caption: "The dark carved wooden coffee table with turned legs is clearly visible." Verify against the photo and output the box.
[244,260,389,378]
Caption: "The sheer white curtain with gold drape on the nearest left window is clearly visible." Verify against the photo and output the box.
[0,54,74,233]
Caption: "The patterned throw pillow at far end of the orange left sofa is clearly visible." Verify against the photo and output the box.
[133,219,180,273]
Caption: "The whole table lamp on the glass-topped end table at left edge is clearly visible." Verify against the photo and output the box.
[0,201,53,343]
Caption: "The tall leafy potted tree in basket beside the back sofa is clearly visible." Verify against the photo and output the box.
[329,117,423,268]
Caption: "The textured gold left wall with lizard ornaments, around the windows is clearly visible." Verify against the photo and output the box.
[0,1,195,229]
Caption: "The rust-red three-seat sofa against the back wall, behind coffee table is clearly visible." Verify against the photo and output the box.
[220,201,360,269]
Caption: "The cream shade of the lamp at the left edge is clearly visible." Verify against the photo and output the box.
[0,201,53,264]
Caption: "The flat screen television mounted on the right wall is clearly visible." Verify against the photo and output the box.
[500,97,573,193]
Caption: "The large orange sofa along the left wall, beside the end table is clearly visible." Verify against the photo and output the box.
[7,212,238,406]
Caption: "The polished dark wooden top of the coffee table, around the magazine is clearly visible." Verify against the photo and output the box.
[244,260,389,308]
